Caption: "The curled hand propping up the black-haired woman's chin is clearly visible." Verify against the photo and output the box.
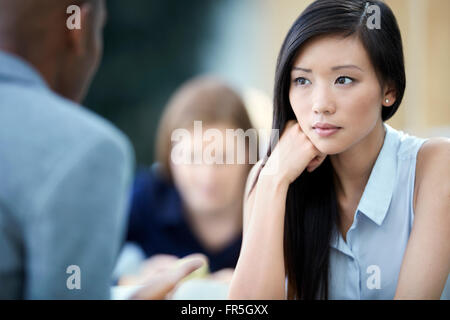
[261,120,327,184]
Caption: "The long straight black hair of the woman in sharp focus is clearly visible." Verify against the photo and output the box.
[255,0,406,299]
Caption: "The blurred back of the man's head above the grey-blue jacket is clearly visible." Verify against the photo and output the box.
[0,0,106,102]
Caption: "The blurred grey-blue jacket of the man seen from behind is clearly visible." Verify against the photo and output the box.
[0,51,134,299]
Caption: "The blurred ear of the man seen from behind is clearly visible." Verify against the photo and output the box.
[68,2,93,56]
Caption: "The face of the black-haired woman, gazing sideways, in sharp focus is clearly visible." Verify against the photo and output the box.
[289,36,395,155]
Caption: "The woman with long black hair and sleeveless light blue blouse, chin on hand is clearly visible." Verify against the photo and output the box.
[229,0,450,299]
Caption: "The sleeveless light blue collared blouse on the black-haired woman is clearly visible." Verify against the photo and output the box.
[328,124,450,299]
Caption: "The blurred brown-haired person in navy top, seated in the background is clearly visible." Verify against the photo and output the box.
[120,76,256,284]
